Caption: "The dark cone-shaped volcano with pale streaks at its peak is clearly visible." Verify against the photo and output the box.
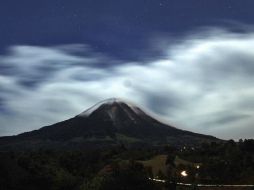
[0,99,218,149]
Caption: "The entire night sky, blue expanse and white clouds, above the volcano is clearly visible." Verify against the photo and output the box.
[0,0,254,139]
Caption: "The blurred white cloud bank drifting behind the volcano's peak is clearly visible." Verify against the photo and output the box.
[0,29,254,139]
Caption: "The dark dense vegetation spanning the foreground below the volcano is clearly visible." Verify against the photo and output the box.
[0,140,254,190]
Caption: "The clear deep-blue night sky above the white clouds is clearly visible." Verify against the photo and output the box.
[0,0,254,60]
